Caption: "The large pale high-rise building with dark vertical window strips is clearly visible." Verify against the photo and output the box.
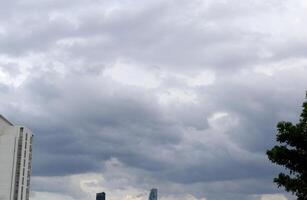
[0,115,33,200]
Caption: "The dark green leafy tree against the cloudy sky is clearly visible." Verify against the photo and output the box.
[267,93,307,200]
